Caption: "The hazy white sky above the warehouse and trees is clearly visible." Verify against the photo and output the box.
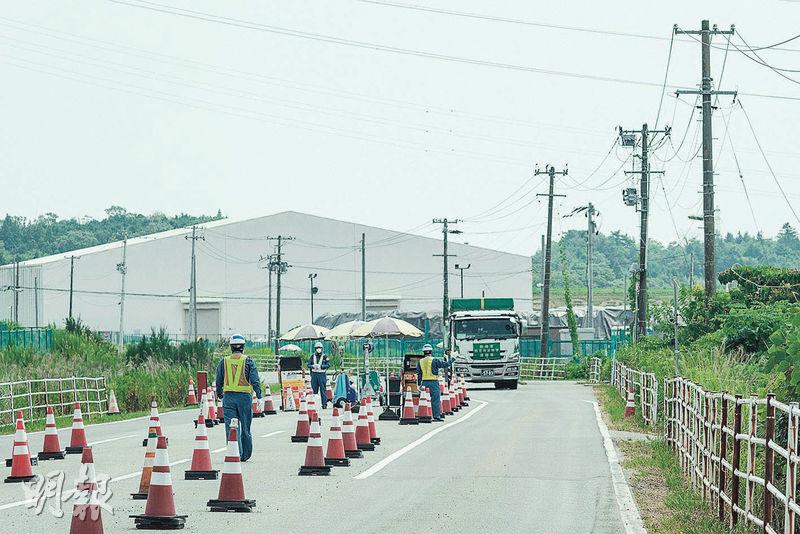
[0,0,800,254]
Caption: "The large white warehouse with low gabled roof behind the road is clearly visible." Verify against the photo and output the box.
[0,211,531,339]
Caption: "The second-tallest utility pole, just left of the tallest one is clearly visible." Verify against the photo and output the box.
[619,123,671,337]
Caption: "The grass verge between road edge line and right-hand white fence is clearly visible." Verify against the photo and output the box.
[594,385,745,534]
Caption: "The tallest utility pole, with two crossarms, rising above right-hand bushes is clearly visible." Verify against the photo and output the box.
[673,20,736,302]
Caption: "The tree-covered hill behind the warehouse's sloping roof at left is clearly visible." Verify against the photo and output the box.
[0,206,223,265]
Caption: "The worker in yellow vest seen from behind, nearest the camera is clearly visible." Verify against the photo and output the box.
[216,334,261,462]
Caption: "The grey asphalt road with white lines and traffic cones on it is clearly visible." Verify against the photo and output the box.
[0,382,636,534]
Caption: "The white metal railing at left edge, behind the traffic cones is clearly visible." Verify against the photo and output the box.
[0,376,108,427]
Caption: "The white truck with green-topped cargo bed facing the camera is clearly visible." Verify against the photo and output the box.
[450,299,523,389]
